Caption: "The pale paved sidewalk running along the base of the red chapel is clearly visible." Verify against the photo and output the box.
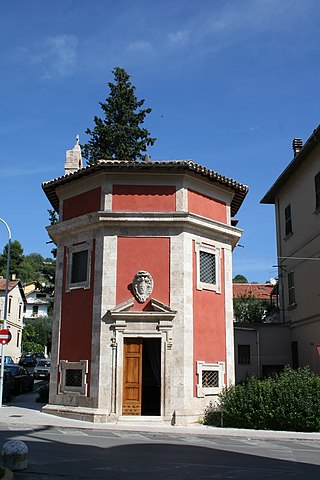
[0,394,320,441]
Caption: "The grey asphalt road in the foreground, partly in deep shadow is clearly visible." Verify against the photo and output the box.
[0,386,320,480]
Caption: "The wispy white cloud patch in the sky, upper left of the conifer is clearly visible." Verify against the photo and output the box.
[19,34,78,79]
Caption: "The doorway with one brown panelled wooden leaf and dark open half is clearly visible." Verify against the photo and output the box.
[122,338,161,415]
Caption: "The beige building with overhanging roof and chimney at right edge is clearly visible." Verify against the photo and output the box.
[261,126,320,373]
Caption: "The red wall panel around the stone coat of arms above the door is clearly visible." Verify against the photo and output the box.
[116,237,170,311]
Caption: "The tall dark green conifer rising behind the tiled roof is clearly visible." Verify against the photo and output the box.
[81,67,156,165]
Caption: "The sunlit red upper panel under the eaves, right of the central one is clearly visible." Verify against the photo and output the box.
[188,190,227,223]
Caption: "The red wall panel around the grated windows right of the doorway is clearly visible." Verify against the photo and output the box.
[193,242,226,396]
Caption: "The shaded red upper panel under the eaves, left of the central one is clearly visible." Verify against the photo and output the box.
[63,187,101,220]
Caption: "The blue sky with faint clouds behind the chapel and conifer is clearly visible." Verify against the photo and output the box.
[0,0,320,282]
